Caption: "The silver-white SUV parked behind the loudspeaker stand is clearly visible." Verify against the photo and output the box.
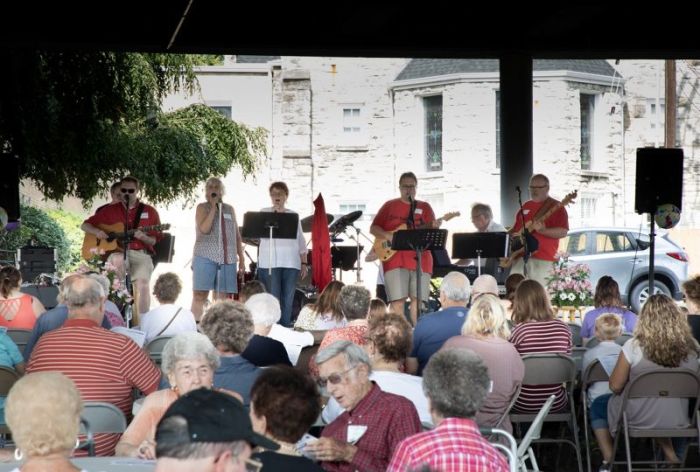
[559,227,688,313]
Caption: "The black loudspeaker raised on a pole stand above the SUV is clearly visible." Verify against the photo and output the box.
[634,148,683,214]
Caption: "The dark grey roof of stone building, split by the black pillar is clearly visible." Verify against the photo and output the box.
[396,59,615,80]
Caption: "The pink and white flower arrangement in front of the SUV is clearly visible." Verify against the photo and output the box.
[547,253,593,308]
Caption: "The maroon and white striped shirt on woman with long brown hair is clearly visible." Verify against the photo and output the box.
[510,320,572,413]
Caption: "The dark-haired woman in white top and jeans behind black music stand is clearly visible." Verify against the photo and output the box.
[258,182,308,327]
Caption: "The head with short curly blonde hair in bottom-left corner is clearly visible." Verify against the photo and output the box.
[7,372,83,472]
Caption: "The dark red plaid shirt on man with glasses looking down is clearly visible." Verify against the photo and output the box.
[321,382,421,472]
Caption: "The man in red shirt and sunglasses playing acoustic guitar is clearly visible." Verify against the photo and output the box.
[80,177,160,313]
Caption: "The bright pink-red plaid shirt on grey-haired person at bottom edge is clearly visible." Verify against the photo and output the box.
[387,418,509,472]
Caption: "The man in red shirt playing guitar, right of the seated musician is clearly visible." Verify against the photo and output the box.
[510,174,569,287]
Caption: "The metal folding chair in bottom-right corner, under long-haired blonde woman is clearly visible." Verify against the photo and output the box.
[610,368,700,472]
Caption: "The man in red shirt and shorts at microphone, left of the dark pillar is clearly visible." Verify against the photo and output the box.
[369,172,440,326]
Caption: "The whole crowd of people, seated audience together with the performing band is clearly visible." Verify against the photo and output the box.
[0,172,700,471]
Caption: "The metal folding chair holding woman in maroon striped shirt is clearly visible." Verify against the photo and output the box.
[510,353,583,472]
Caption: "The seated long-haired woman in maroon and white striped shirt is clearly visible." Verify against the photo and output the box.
[510,280,572,413]
